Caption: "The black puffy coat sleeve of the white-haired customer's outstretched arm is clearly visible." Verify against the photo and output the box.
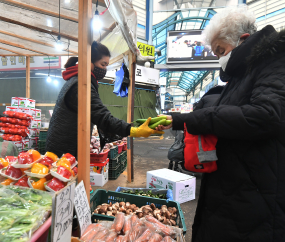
[170,62,285,140]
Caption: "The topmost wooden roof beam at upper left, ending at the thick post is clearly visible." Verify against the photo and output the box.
[0,0,111,32]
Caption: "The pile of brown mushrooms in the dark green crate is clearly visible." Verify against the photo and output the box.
[94,202,177,226]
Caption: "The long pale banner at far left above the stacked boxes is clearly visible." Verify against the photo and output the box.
[0,56,61,71]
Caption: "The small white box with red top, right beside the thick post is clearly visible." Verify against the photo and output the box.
[90,159,109,187]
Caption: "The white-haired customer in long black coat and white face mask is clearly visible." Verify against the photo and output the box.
[157,7,285,242]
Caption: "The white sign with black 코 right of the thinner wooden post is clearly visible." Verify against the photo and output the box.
[135,65,159,85]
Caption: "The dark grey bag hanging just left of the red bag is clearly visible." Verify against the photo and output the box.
[167,131,184,161]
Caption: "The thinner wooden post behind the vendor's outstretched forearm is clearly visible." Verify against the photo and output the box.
[127,51,136,182]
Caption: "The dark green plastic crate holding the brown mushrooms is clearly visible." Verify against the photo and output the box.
[90,189,187,235]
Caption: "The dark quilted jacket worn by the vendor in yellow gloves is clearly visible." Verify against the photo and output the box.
[46,76,131,157]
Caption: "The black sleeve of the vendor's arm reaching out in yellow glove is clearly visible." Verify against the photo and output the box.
[65,83,131,137]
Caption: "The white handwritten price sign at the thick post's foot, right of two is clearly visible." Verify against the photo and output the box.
[74,181,91,235]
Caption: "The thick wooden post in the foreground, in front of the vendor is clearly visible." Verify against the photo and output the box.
[77,0,92,201]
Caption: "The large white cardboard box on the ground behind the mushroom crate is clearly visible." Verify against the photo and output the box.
[146,169,196,203]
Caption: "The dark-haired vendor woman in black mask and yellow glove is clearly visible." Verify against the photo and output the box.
[46,41,161,157]
